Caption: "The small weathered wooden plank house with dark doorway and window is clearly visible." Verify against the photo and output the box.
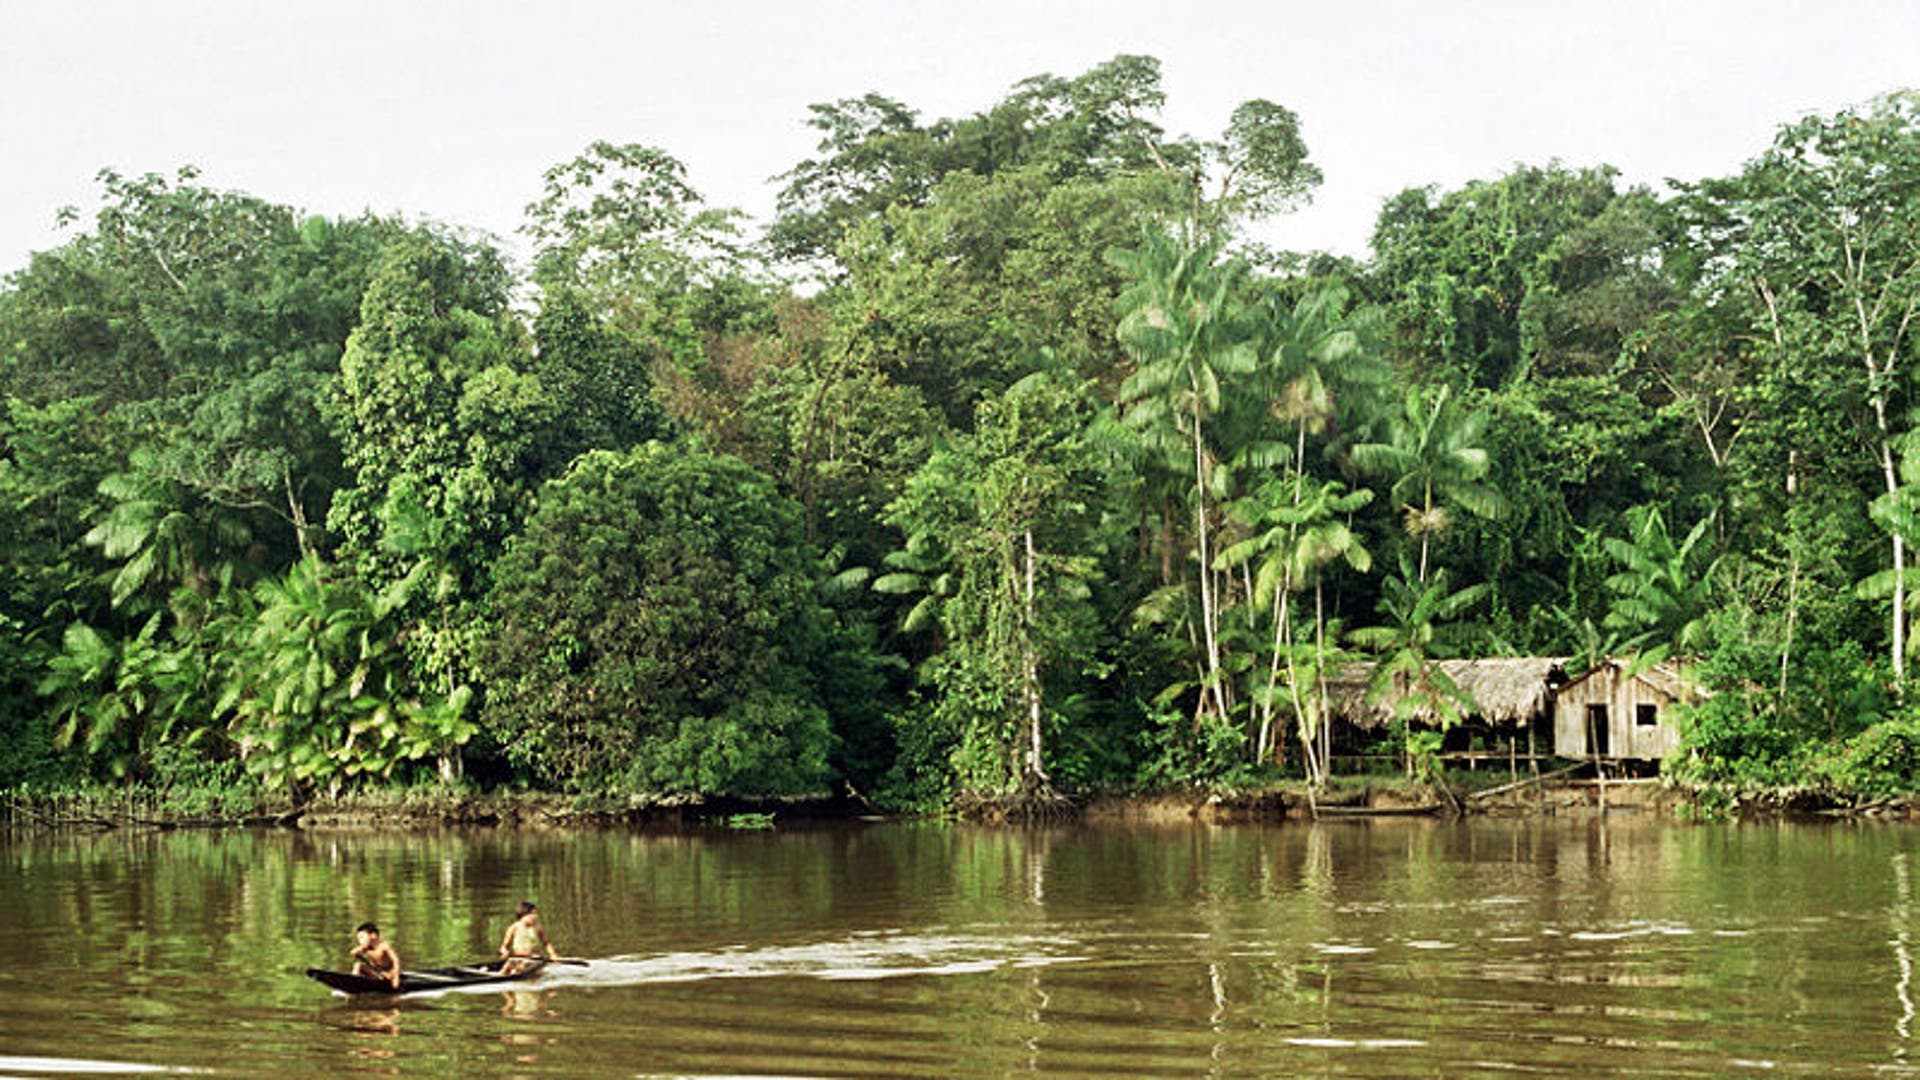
[1553,659,1701,761]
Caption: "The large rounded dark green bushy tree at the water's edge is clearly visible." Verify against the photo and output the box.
[482,442,831,794]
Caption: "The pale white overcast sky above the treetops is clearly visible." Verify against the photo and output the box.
[0,0,1920,271]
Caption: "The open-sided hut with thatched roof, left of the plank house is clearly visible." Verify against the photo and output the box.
[1327,657,1567,753]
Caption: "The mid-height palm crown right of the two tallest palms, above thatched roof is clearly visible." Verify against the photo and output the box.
[1354,386,1507,582]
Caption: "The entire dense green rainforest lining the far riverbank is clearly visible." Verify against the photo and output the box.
[0,56,1920,809]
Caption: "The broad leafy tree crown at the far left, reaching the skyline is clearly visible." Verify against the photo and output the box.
[0,169,405,557]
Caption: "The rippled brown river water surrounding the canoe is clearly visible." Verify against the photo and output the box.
[0,817,1920,1078]
